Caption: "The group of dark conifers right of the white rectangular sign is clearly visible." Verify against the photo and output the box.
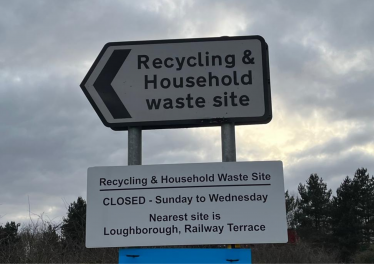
[285,168,374,262]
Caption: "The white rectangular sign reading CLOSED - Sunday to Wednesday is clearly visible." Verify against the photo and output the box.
[86,161,287,248]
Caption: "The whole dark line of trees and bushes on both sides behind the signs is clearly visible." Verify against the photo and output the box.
[0,168,374,263]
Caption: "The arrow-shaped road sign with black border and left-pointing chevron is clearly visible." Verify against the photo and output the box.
[81,36,272,130]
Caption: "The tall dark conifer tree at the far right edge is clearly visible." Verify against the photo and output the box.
[331,168,374,261]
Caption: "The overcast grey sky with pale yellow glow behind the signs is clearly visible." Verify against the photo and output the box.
[0,0,374,224]
